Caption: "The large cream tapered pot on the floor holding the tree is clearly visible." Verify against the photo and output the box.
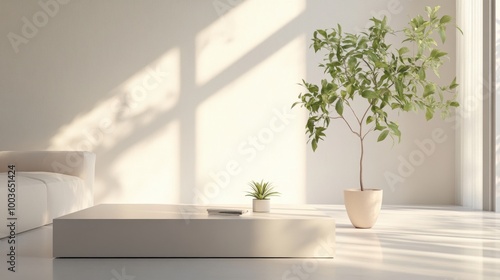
[344,189,383,228]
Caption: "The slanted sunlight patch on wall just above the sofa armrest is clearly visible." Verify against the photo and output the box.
[48,48,180,151]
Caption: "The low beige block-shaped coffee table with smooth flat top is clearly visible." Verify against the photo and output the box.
[53,204,335,258]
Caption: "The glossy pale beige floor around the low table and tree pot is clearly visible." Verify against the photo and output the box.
[0,206,500,280]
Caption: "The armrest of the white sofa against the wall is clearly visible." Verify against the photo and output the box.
[0,151,96,200]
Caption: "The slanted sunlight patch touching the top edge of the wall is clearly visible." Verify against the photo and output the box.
[196,0,306,86]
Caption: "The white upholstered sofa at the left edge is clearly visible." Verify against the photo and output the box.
[0,151,96,238]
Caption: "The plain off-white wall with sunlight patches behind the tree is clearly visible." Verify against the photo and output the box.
[0,0,455,204]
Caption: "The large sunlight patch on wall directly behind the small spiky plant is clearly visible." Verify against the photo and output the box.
[195,35,307,204]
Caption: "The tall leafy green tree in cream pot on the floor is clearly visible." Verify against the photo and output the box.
[292,6,459,228]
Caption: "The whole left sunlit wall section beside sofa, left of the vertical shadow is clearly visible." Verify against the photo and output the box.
[48,48,180,203]
